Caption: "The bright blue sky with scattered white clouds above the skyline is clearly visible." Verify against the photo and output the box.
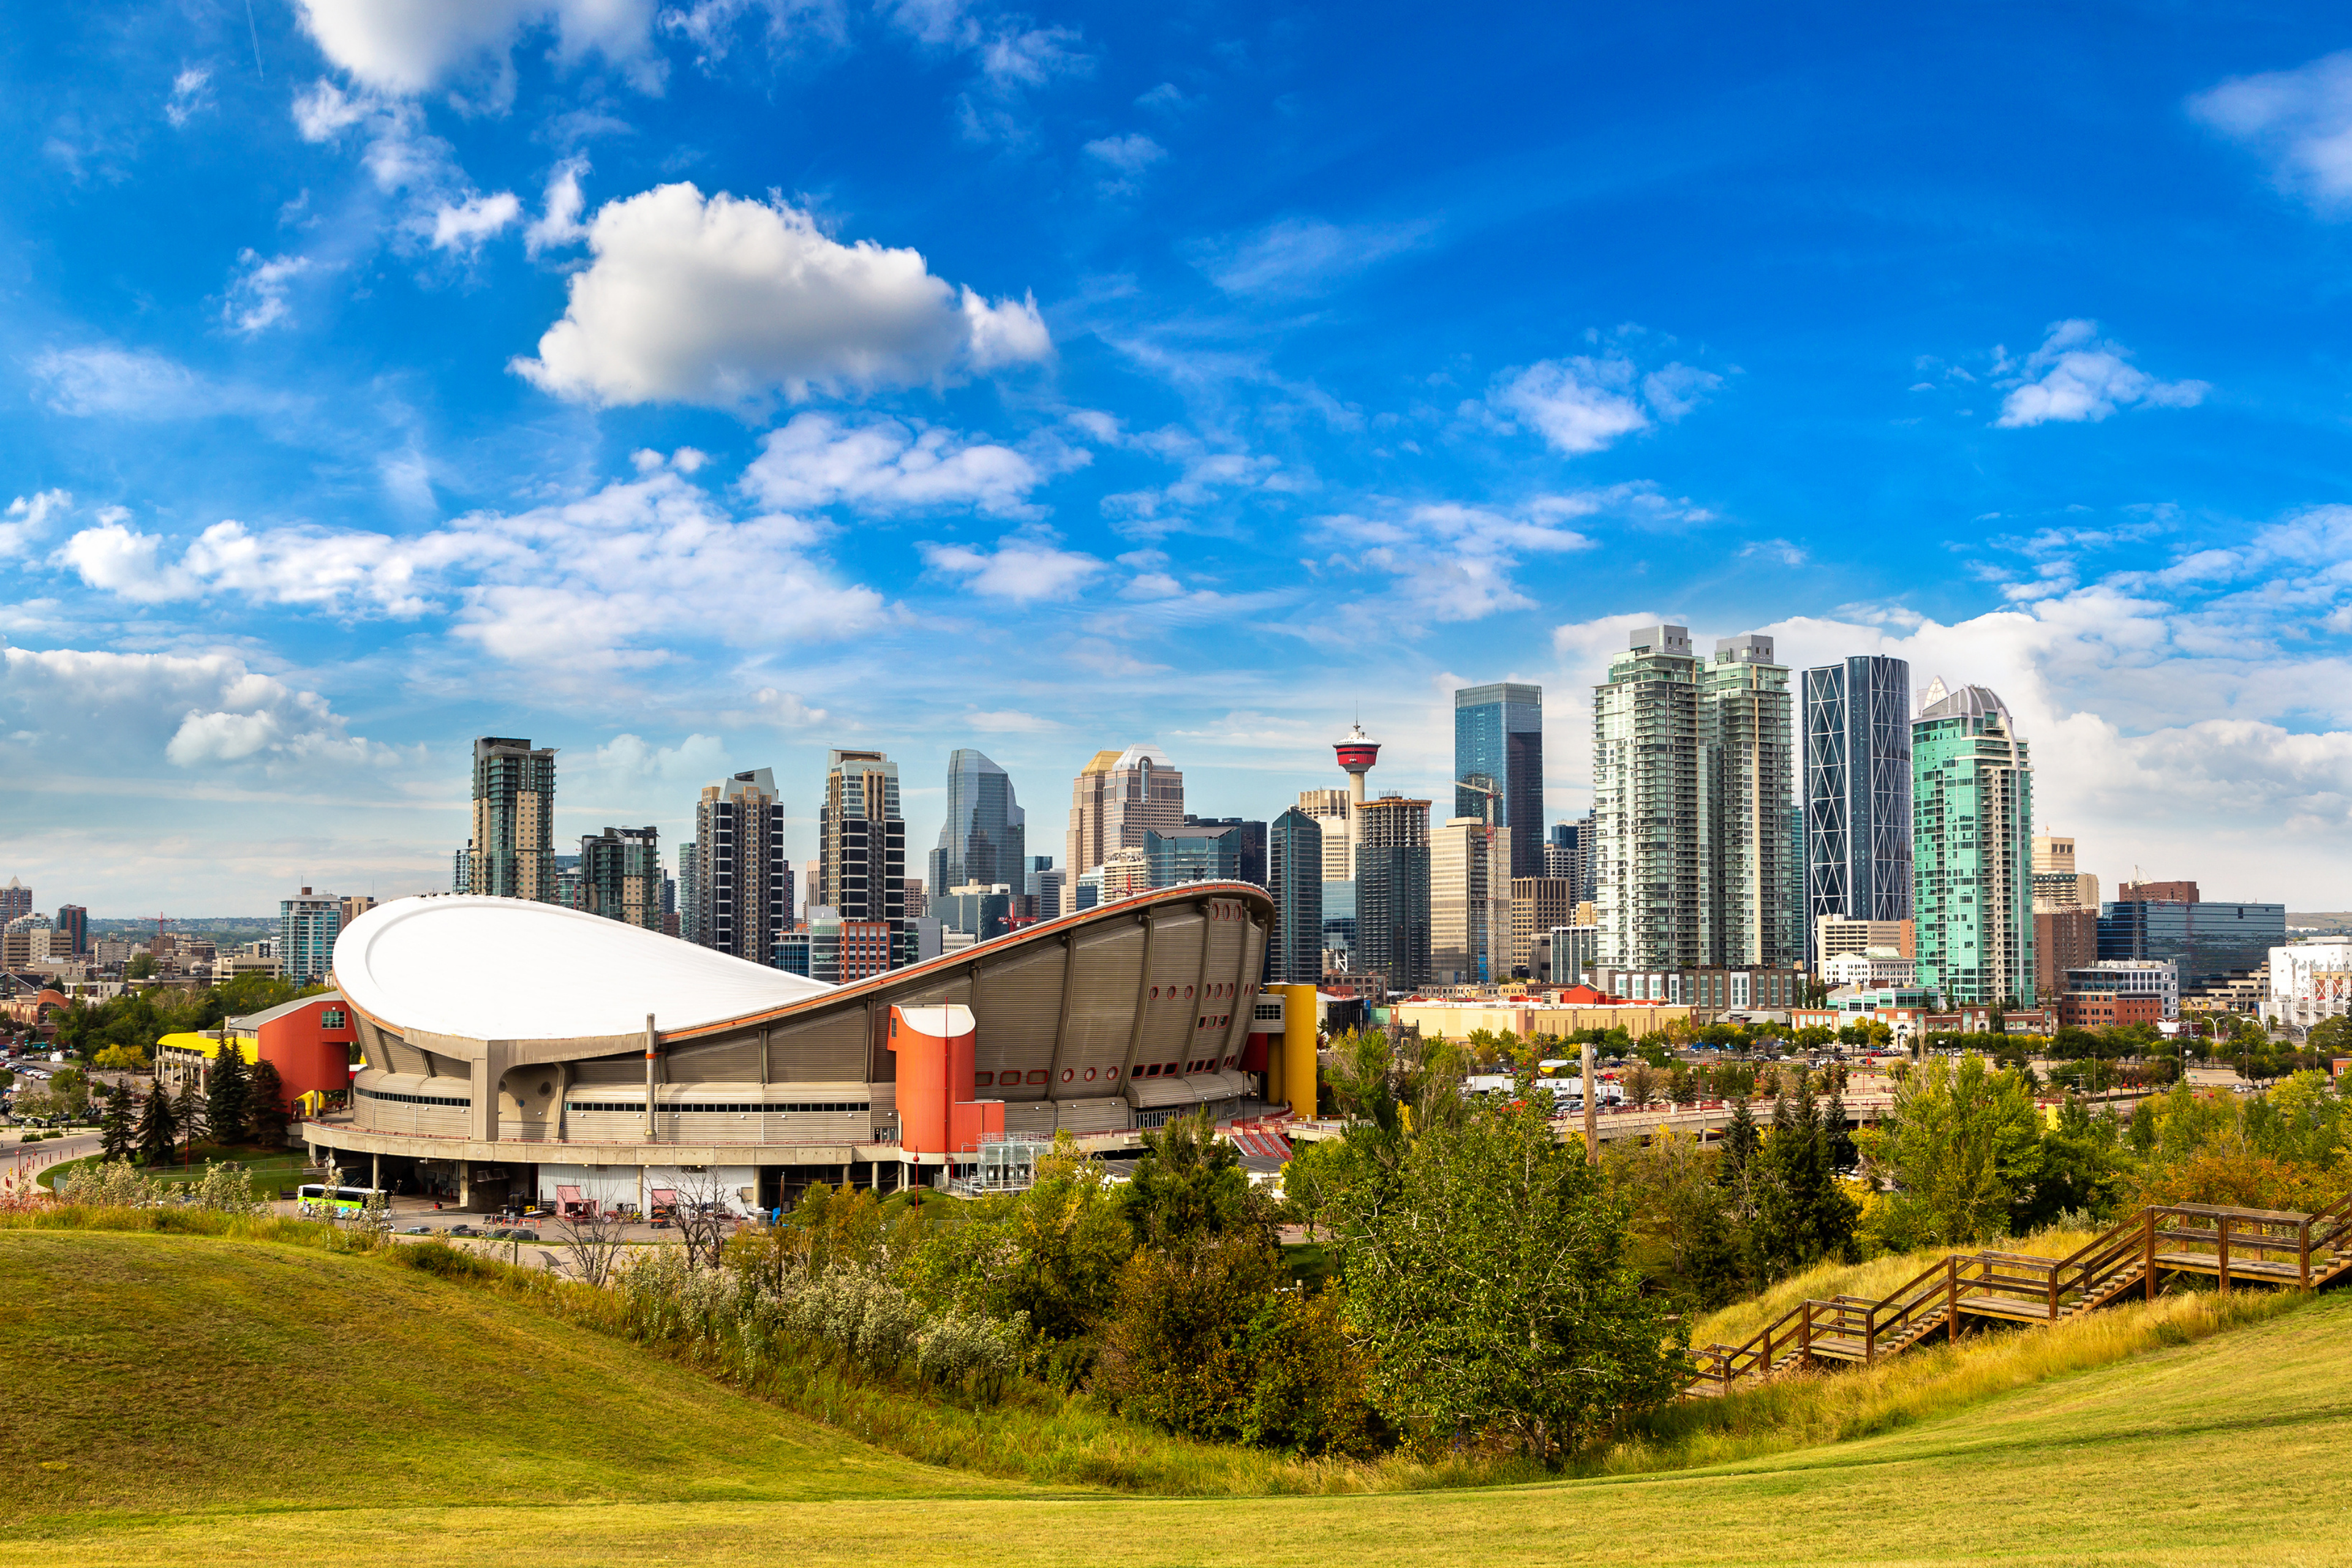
[0,0,2352,914]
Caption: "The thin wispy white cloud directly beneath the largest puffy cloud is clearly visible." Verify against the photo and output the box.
[743,414,1049,515]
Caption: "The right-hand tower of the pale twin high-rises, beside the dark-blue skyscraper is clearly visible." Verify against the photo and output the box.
[1698,632,1804,968]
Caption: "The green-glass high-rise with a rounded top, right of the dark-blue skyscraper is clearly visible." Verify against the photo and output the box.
[1912,679,2037,1009]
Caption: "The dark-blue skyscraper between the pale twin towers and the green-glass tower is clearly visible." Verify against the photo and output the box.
[1800,654,1912,962]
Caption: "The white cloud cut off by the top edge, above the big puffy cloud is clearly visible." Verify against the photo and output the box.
[296,0,661,94]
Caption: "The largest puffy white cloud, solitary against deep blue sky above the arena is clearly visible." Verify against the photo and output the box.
[513,183,1051,407]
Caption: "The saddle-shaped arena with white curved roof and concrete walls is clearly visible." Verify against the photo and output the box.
[296,881,1280,1213]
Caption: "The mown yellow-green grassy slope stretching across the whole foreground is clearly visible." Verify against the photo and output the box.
[0,1232,2352,1568]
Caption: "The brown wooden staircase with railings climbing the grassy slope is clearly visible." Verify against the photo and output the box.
[1684,1197,2352,1399]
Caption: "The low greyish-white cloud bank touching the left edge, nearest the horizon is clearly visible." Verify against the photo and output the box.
[0,649,372,769]
